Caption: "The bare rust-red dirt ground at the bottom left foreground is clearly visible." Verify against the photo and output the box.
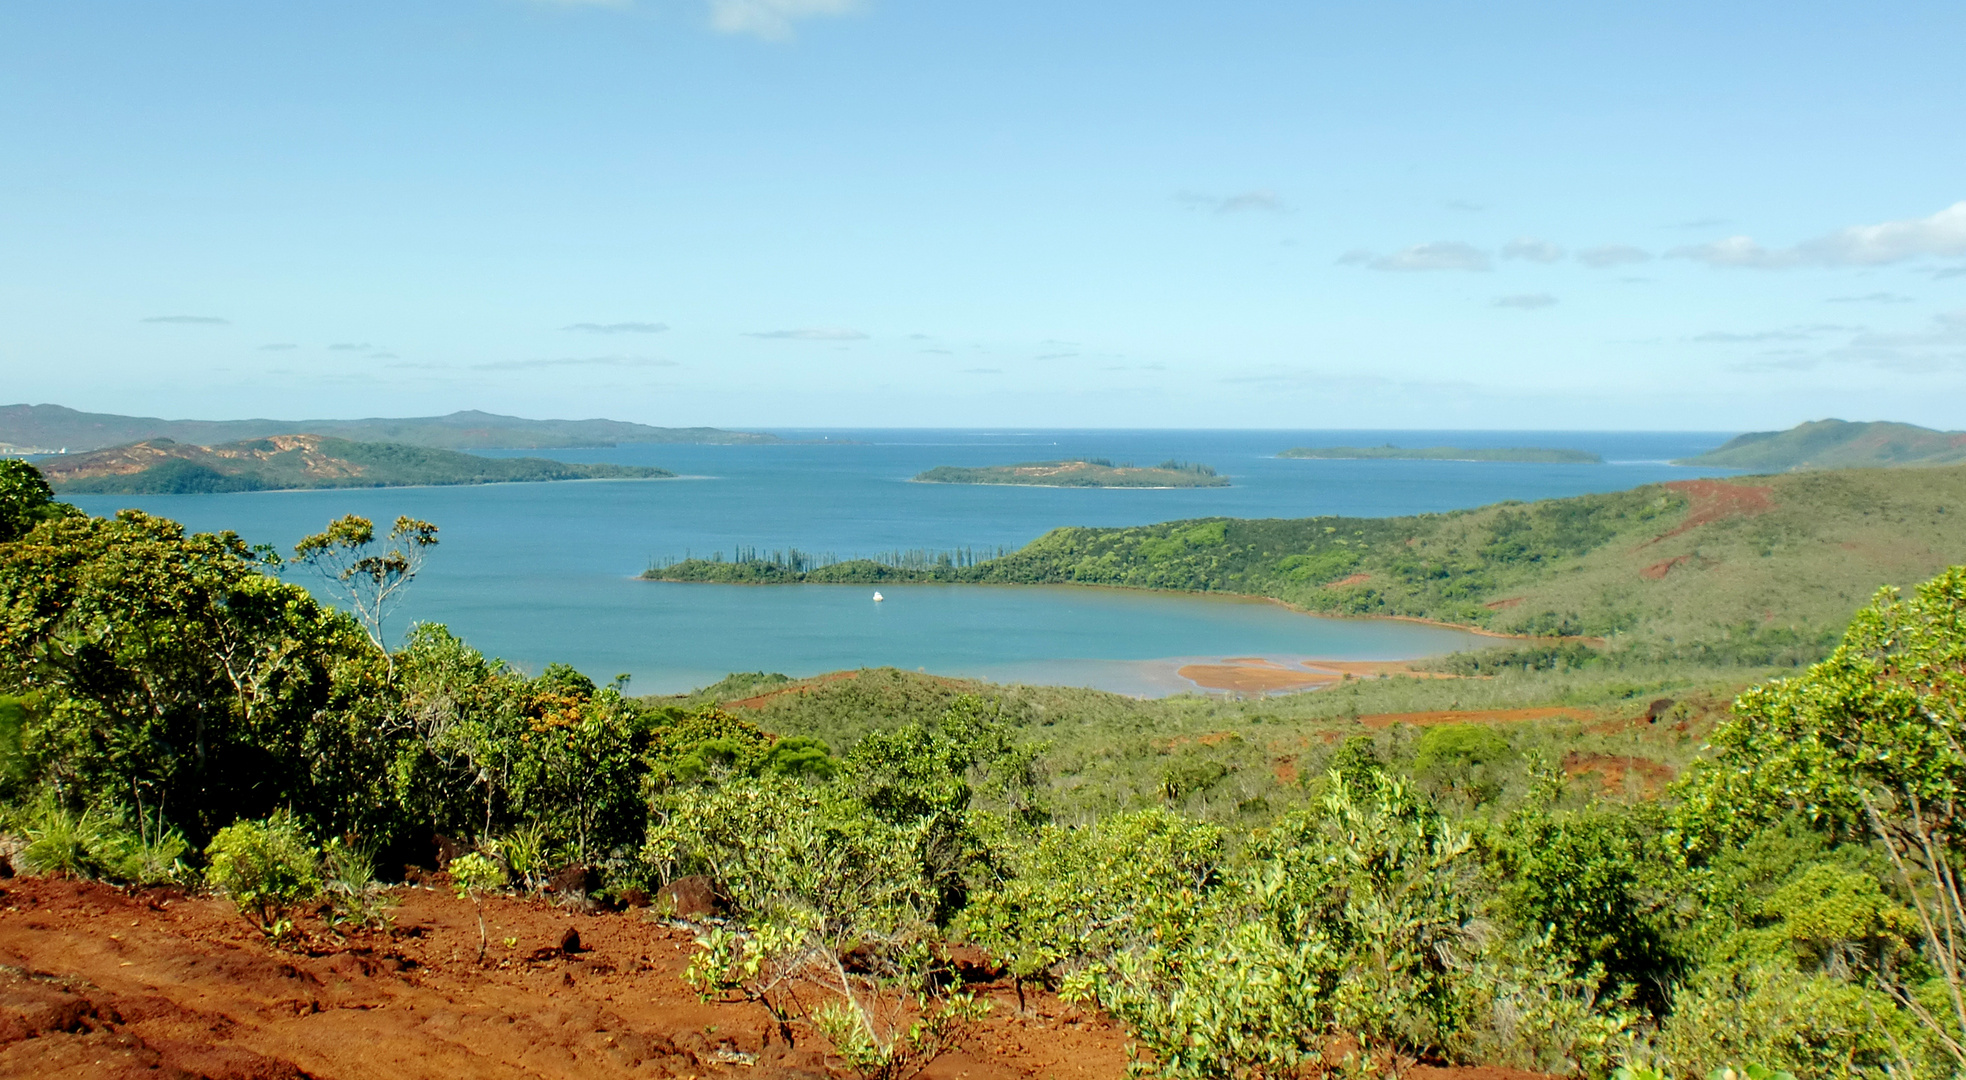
[0,877,1125,1080]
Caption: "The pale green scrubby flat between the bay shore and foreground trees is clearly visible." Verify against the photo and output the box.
[653,665,1764,822]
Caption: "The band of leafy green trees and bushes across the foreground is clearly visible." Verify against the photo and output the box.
[0,474,1966,1078]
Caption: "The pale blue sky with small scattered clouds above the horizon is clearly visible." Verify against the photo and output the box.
[0,0,1966,431]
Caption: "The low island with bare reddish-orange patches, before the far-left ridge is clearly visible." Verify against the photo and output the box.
[37,435,674,496]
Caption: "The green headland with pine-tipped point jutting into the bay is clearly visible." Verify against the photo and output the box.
[649,468,1966,663]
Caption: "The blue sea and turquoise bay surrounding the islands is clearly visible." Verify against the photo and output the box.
[73,429,1730,694]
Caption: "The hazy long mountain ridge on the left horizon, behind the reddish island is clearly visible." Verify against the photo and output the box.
[0,405,782,454]
